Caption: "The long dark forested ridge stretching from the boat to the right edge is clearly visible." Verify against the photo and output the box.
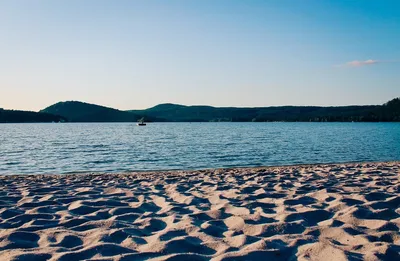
[131,98,400,122]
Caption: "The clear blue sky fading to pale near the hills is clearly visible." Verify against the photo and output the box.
[0,0,400,111]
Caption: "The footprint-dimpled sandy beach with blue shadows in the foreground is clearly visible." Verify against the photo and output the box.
[0,162,400,261]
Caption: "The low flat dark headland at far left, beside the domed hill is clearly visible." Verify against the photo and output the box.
[0,108,66,123]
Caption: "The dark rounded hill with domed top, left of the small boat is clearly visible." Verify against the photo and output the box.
[40,101,141,122]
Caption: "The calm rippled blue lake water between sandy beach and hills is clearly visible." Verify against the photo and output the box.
[0,123,400,174]
